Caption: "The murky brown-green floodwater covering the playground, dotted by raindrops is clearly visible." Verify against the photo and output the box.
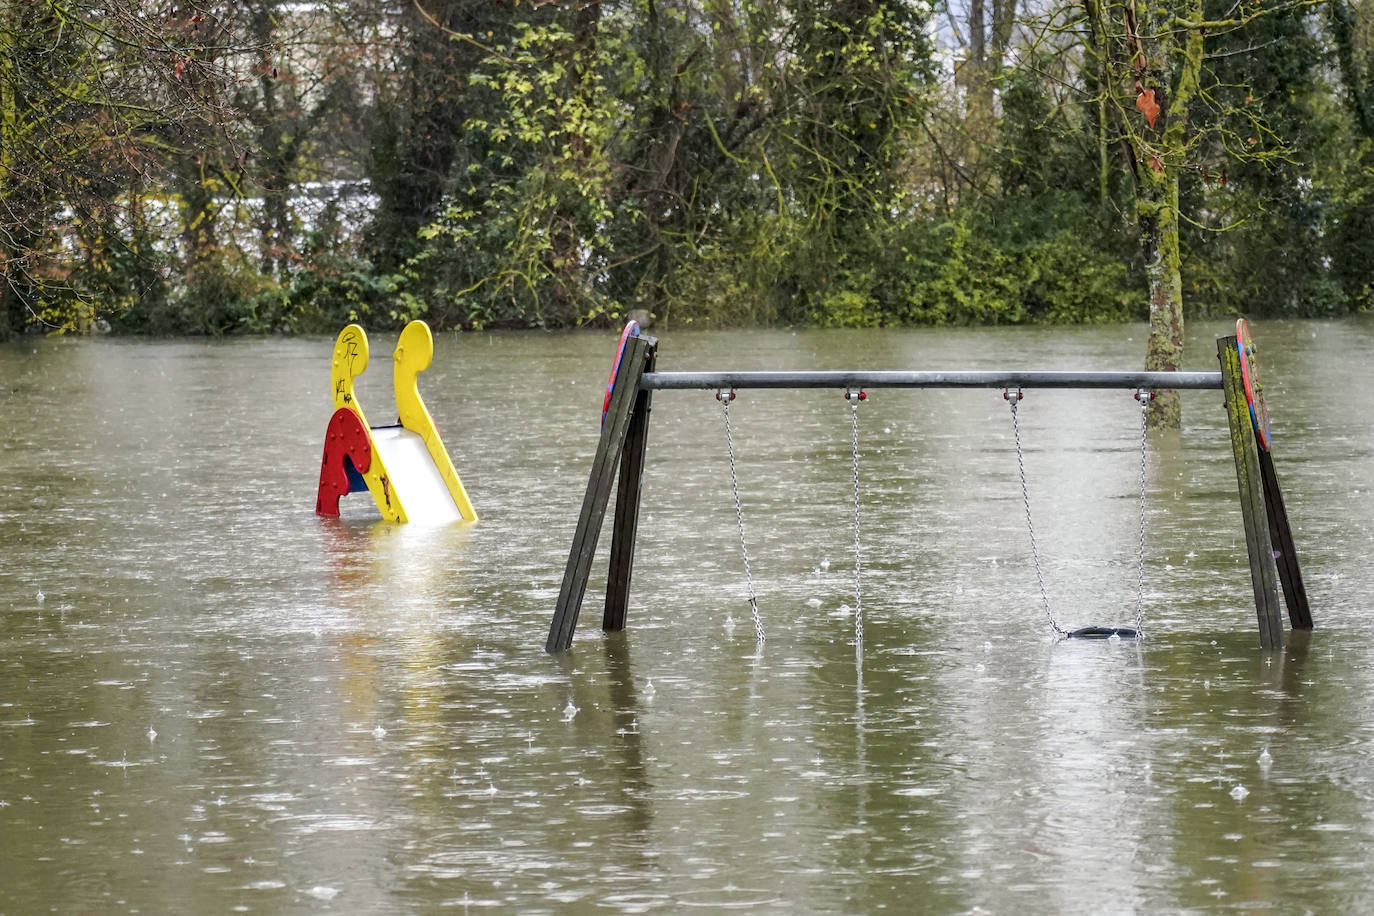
[0,317,1374,913]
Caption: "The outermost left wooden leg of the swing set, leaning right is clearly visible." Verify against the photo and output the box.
[544,336,658,652]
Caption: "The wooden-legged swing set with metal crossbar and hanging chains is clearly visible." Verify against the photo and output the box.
[544,319,1312,652]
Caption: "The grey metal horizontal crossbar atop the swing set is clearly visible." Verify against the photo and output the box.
[639,369,1221,391]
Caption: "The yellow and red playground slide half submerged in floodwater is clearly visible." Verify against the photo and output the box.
[316,321,477,525]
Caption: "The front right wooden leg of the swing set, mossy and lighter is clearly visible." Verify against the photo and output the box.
[1216,336,1283,650]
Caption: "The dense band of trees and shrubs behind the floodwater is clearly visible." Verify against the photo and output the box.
[0,0,1374,340]
